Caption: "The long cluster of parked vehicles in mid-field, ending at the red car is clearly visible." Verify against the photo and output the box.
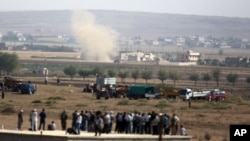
[83,78,227,101]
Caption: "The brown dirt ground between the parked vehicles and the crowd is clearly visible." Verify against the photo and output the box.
[0,78,250,141]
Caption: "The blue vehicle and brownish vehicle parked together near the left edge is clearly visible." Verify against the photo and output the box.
[0,76,36,94]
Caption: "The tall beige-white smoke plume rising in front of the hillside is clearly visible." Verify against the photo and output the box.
[72,10,118,62]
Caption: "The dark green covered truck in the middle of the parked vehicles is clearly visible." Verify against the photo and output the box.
[127,85,161,99]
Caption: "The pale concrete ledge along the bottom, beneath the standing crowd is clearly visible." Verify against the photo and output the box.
[0,130,191,141]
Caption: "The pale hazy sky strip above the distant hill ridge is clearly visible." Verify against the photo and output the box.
[0,0,250,18]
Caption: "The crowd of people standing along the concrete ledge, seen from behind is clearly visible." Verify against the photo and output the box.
[17,108,187,136]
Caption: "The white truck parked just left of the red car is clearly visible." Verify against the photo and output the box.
[179,88,211,100]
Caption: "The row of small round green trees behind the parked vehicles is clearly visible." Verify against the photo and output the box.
[63,65,250,87]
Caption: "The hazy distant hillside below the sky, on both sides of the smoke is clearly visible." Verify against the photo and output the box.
[0,10,250,38]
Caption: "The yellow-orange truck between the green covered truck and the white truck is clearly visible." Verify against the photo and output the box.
[160,88,179,99]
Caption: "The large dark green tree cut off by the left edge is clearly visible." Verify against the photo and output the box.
[0,52,19,76]
